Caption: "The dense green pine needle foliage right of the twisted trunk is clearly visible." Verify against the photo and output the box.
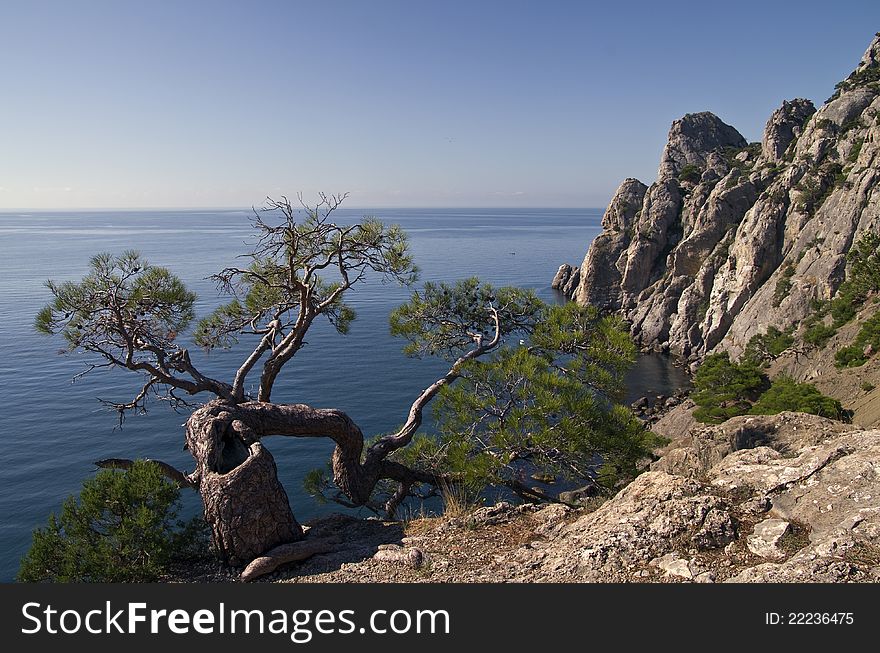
[395,300,661,494]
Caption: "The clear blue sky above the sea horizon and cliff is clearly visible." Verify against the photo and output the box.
[0,0,880,209]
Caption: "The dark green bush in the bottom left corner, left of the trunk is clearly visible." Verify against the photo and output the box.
[18,461,204,583]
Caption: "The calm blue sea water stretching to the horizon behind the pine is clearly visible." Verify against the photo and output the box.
[0,209,683,581]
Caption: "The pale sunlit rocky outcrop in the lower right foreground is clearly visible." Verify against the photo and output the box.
[498,413,880,582]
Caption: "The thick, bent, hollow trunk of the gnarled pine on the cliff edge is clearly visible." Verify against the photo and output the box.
[186,400,450,566]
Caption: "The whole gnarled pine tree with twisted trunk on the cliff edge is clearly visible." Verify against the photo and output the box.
[36,195,646,576]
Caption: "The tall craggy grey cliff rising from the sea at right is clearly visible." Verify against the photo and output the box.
[554,36,880,360]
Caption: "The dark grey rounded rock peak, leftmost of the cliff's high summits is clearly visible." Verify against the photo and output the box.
[657,111,748,181]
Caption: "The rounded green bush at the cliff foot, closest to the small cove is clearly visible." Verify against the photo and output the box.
[691,353,767,424]
